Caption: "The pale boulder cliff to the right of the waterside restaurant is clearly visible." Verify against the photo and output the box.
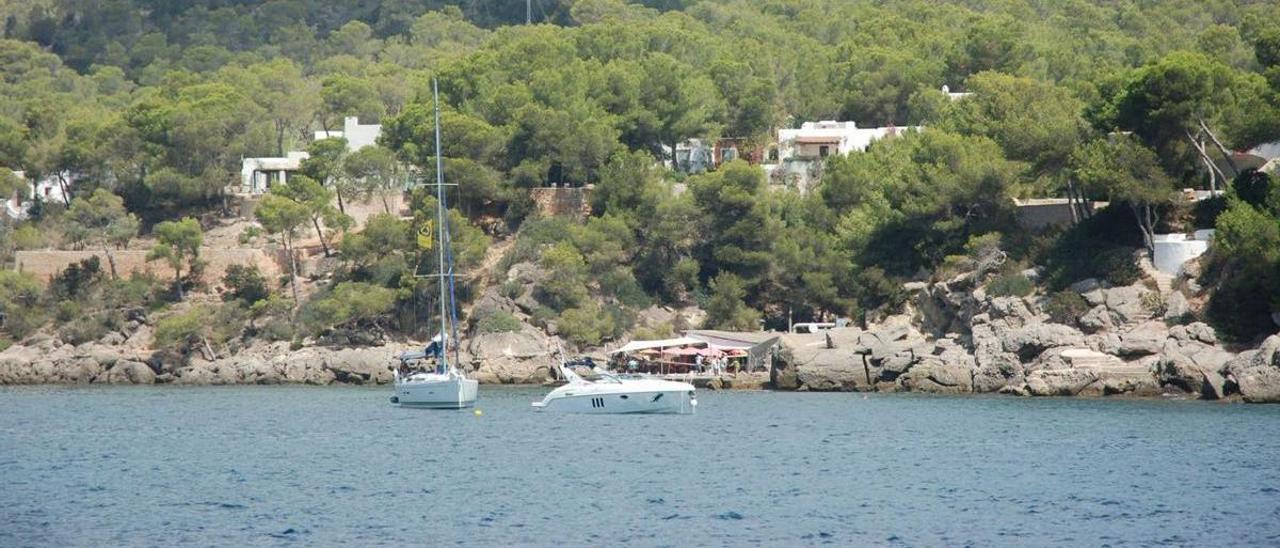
[773,277,1280,402]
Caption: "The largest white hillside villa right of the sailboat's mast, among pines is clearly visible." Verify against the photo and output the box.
[763,120,920,189]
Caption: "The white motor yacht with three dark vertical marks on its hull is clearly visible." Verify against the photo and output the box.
[534,362,698,415]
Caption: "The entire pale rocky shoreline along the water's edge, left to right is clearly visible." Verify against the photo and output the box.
[0,277,1280,402]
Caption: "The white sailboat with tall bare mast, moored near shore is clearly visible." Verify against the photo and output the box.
[392,79,480,408]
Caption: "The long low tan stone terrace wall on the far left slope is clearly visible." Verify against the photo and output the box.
[14,247,284,283]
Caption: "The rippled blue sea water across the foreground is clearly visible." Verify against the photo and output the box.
[0,387,1280,547]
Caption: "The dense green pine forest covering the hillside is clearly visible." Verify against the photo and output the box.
[0,0,1280,353]
